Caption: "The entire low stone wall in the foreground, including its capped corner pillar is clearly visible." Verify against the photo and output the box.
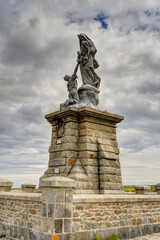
[0,177,160,240]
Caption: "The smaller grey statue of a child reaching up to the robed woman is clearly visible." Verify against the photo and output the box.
[60,72,79,109]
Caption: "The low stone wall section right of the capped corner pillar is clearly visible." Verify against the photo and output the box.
[72,194,160,239]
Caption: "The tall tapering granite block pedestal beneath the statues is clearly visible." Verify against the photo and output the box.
[42,107,123,193]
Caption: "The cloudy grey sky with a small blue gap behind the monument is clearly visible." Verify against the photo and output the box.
[0,0,160,187]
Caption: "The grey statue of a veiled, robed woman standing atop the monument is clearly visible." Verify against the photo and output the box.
[77,33,101,88]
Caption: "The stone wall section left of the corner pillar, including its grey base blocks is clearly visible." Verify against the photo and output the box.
[0,191,53,240]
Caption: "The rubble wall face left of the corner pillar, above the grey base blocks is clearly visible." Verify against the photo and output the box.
[0,192,41,230]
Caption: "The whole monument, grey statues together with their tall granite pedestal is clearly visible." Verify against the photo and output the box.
[40,33,124,193]
